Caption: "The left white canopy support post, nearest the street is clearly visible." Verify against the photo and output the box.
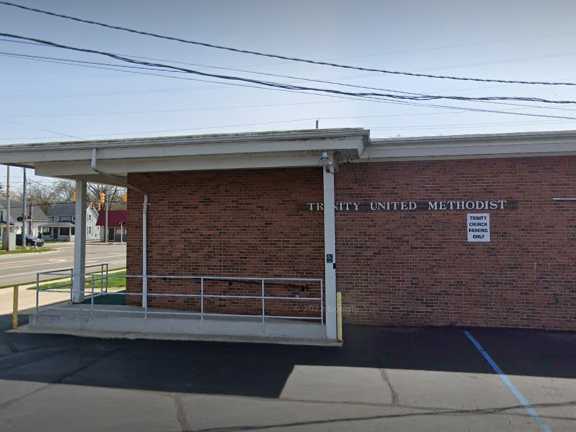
[69,179,86,303]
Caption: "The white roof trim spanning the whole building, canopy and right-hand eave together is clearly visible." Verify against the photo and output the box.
[0,128,576,184]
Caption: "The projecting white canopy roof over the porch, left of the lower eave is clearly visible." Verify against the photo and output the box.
[0,129,369,184]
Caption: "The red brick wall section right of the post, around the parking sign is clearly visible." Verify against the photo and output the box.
[336,157,576,329]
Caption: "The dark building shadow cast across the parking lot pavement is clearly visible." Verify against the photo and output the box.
[0,315,576,398]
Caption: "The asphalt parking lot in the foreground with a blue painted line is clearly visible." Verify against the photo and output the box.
[0,316,576,432]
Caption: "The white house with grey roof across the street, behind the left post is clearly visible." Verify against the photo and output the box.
[42,203,100,241]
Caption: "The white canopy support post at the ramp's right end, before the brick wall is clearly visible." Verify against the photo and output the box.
[321,155,338,340]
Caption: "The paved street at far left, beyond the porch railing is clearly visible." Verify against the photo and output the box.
[0,242,126,286]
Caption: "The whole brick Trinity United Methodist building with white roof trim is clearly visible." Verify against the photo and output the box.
[0,129,576,339]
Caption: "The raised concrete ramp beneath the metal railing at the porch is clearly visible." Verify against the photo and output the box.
[16,304,341,346]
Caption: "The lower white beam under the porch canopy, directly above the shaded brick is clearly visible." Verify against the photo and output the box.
[36,152,320,177]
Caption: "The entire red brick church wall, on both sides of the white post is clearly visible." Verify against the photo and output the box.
[128,157,576,329]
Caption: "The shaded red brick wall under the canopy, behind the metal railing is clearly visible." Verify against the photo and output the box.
[128,169,323,316]
